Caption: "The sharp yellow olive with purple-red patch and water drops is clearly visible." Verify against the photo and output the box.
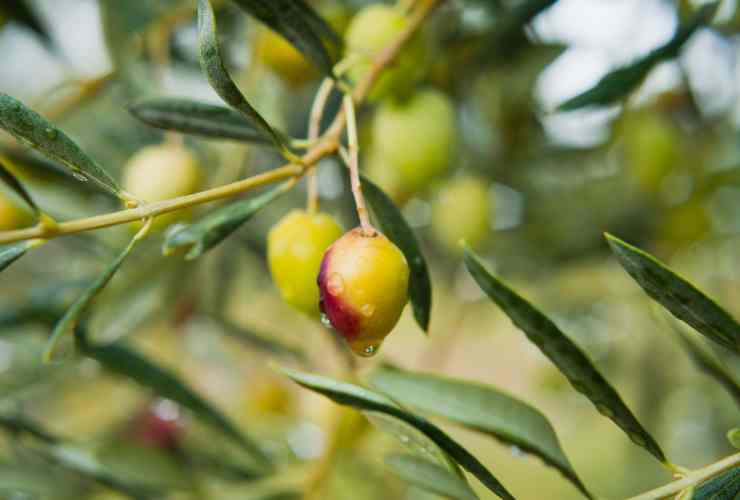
[318,228,409,357]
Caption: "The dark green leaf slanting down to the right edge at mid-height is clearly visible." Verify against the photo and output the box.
[606,234,740,354]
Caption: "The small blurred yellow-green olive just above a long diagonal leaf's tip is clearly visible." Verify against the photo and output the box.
[432,176,492,253]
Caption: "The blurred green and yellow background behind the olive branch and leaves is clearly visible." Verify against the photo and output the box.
[0,0,740,500]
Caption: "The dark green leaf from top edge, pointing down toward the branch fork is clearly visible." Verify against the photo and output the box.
[234,0,340,77]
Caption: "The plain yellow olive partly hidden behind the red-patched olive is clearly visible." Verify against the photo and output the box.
[267,210,343,318]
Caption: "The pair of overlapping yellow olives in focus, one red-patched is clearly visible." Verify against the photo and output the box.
[267,210,409,356]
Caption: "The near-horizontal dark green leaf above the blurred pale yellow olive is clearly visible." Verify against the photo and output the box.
[128,97,272,144]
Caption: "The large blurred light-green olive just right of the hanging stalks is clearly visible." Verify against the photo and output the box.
[373,89,457,192]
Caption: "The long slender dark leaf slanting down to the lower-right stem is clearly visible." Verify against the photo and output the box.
[465,248,668,464]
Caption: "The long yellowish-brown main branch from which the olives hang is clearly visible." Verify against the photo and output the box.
[0,0,444,244]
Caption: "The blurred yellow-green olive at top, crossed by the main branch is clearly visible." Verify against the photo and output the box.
[345,3,427,101]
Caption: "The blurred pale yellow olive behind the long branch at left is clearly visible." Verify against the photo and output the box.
[123,144,203,229]
